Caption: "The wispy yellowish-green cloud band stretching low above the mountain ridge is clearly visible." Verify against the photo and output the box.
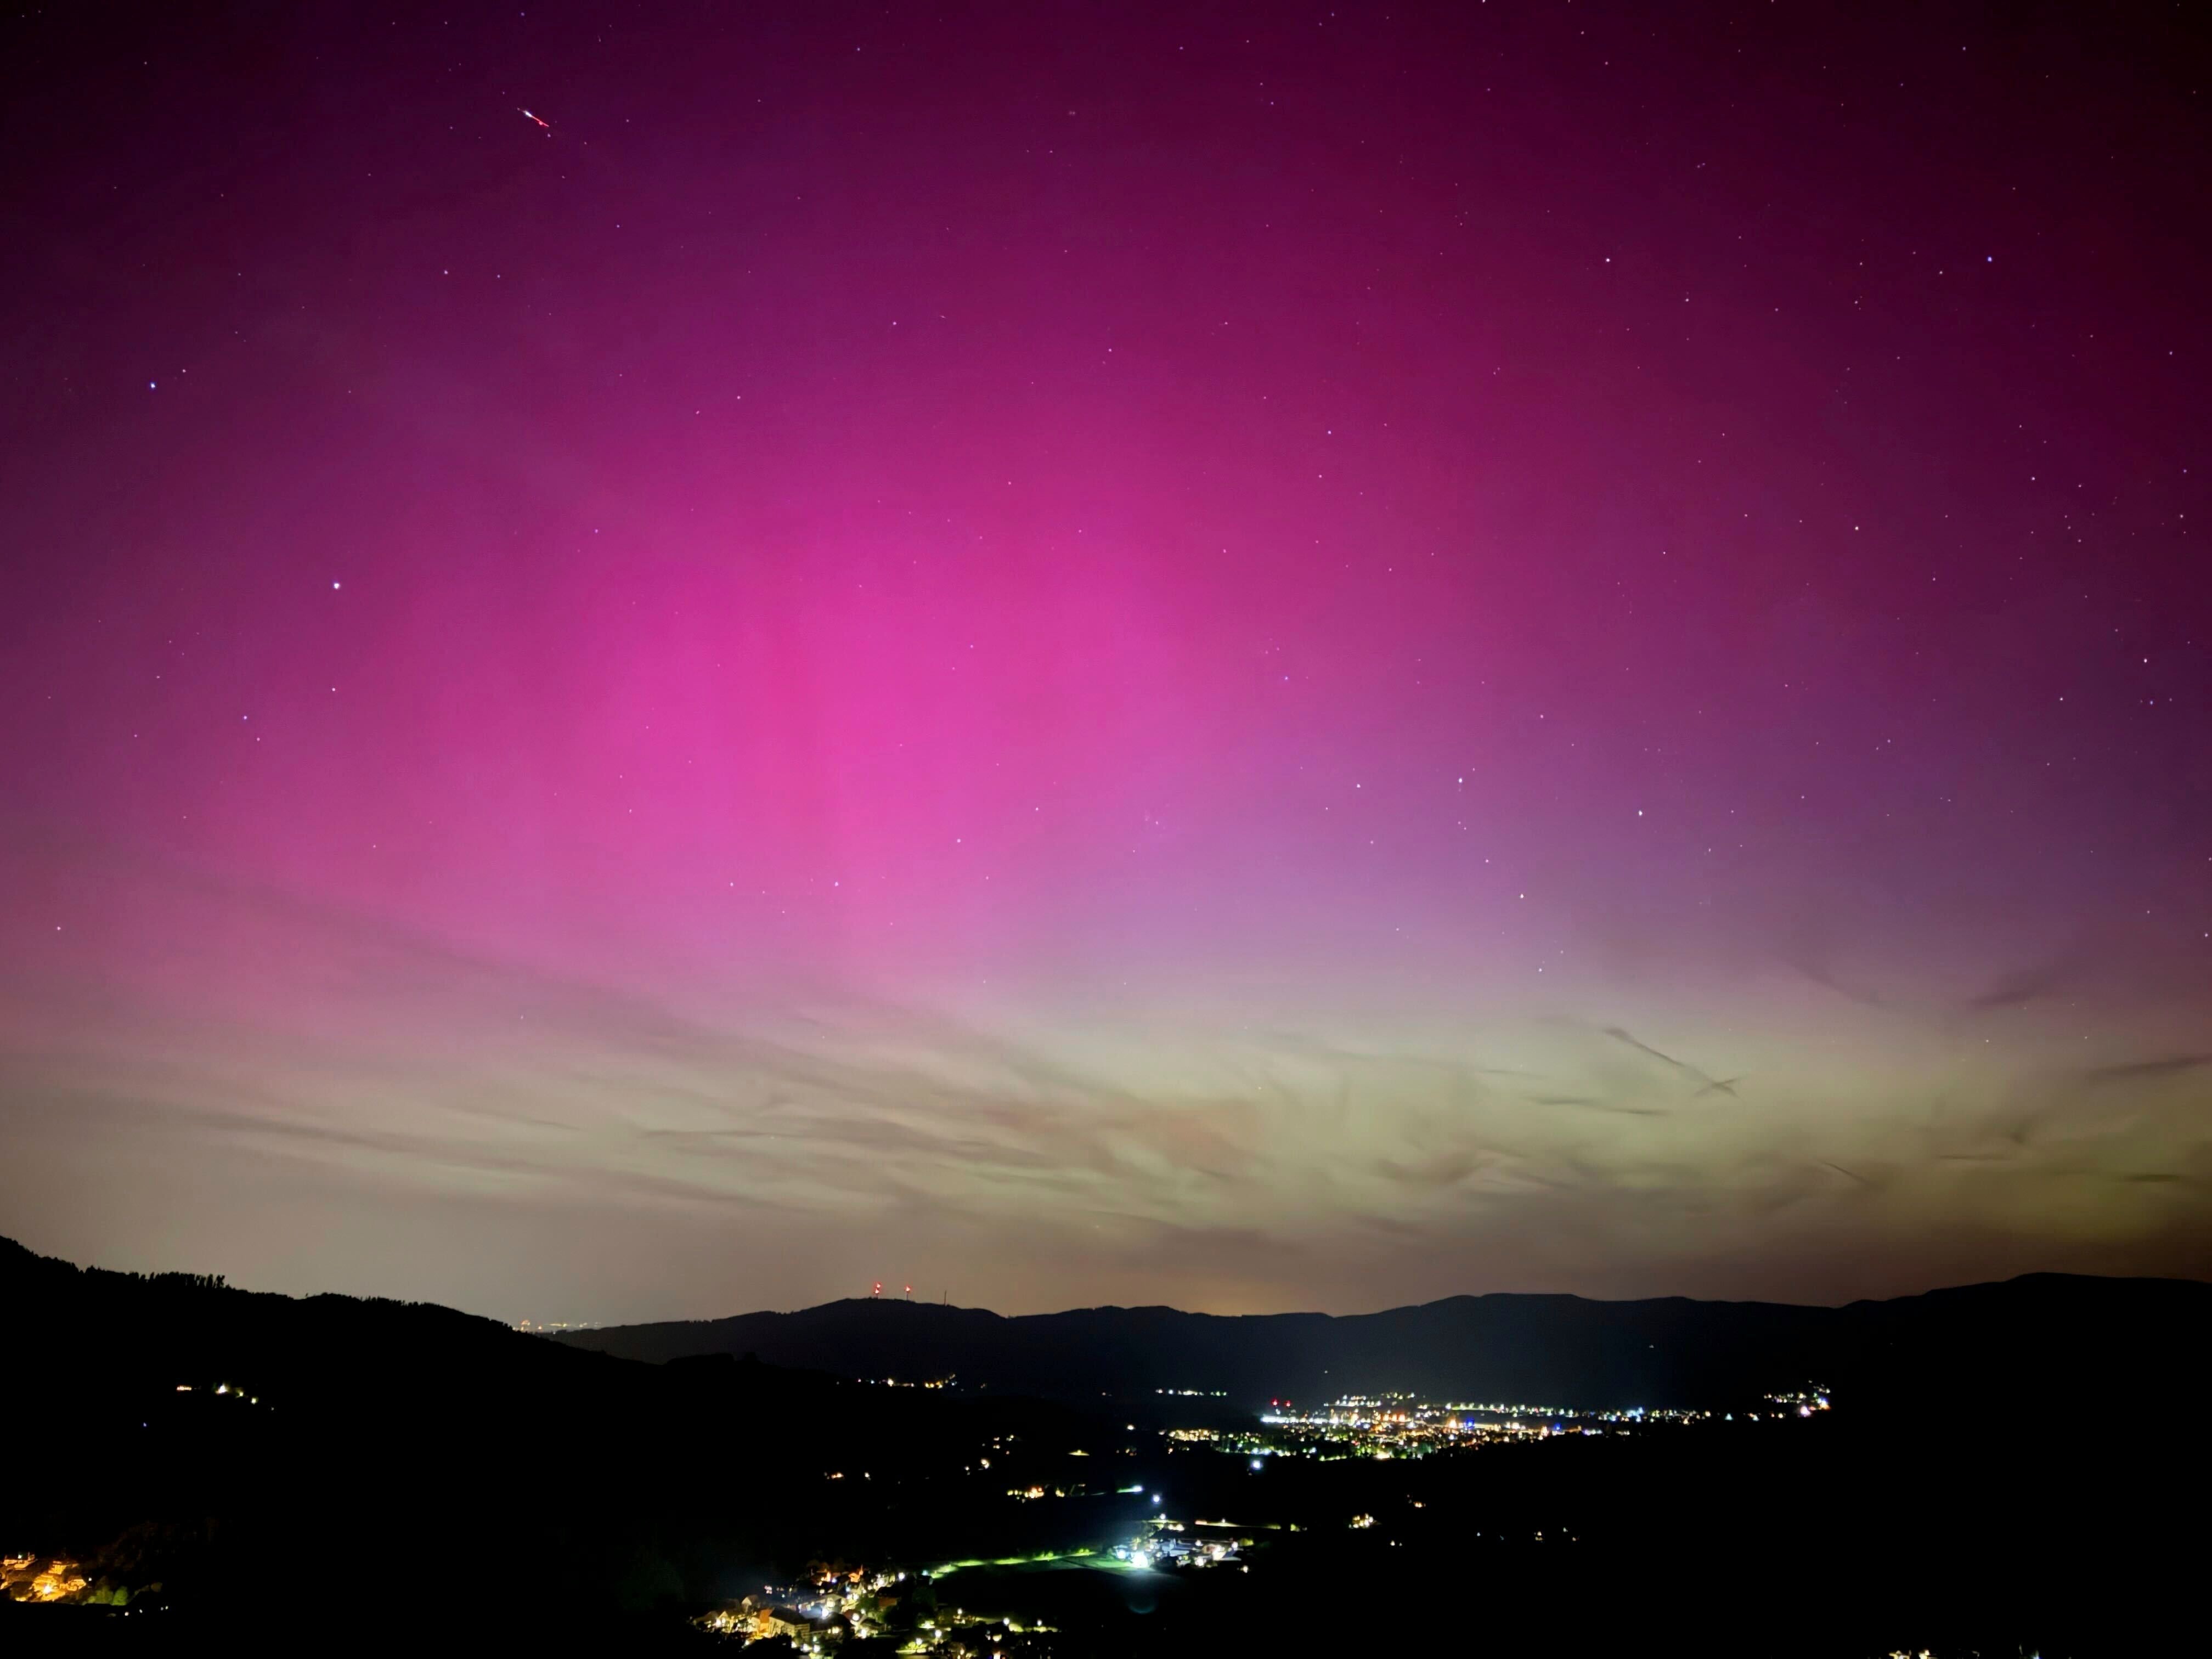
[0,836,2212,1305]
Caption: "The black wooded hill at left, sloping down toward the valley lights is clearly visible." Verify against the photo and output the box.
[0,1241,1119,1644]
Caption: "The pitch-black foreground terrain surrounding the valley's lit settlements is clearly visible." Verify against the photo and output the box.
[0,1245,2212,1659]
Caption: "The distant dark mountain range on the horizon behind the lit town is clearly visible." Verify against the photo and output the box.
[557,1274,2212,1409]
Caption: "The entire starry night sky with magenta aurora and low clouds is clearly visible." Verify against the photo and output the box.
[0,0,2212,1321]
